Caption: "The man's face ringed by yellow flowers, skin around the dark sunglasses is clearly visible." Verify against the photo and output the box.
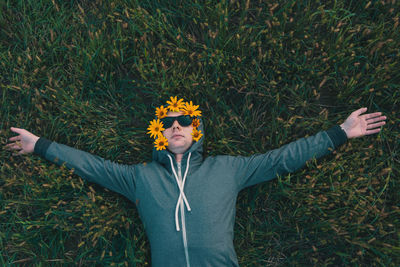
[163,111,193,154]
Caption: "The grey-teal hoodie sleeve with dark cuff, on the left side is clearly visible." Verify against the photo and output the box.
[34,137,136,203]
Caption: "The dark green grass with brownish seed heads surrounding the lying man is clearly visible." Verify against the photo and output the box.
[0,0,400,266]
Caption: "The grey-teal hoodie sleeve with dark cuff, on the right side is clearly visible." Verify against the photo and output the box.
[236,126,347,190]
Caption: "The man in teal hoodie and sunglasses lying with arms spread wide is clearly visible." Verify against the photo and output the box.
[6,99,386,267]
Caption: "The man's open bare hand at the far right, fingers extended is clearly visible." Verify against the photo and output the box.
[340,108,386,138]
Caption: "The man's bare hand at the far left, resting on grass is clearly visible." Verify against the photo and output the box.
[4,127,39,156]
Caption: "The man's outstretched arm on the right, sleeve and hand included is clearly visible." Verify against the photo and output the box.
[235,108,386,189]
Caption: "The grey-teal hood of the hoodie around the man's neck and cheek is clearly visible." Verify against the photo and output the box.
[153,118,205,172]
